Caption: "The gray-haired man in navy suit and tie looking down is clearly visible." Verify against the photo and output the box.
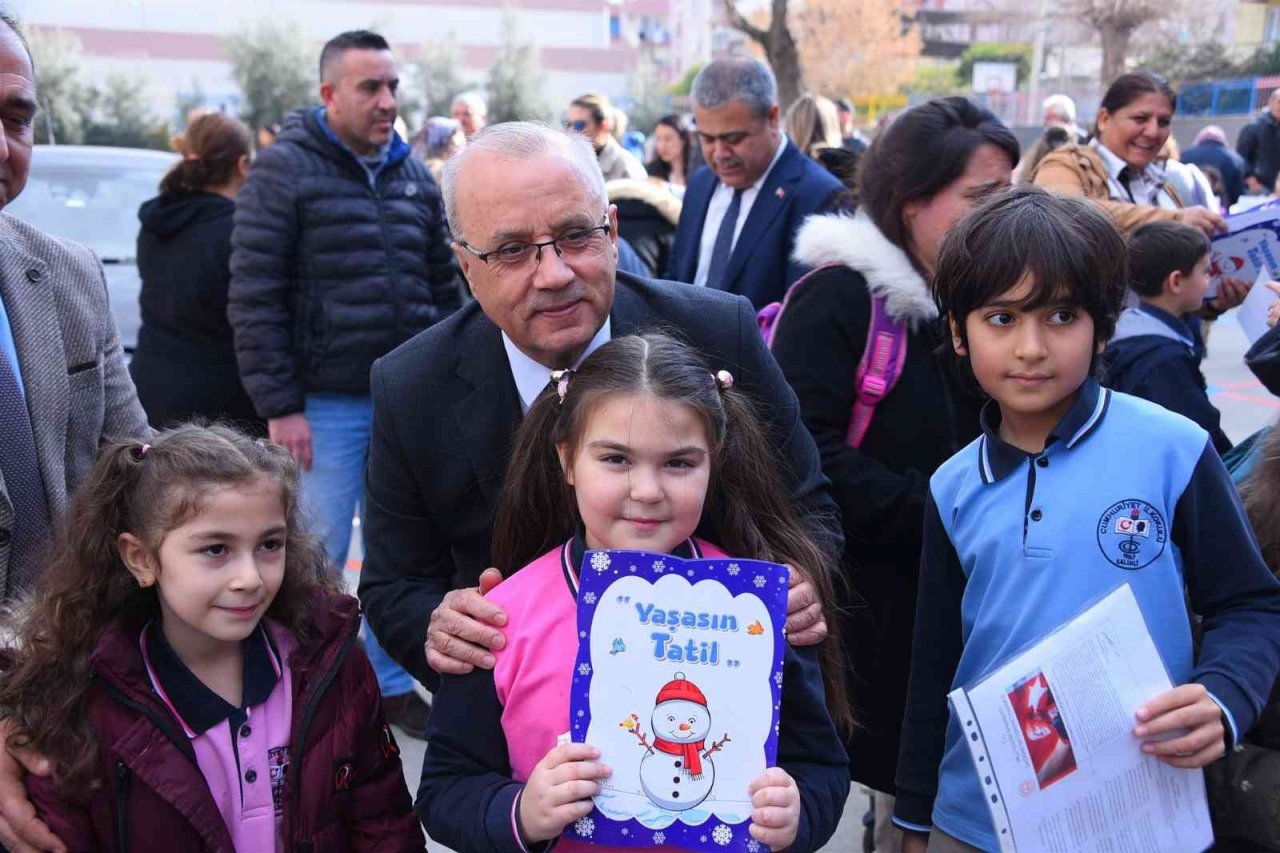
[669,58,844,309]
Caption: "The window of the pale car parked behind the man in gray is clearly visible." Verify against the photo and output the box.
[5,163,166,260]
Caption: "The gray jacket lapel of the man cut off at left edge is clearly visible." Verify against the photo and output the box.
[0,220,69,512]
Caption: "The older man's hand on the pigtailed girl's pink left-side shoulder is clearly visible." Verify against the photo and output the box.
[425,569,507,675]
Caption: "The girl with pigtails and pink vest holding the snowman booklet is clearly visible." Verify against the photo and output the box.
[417,334,849,853]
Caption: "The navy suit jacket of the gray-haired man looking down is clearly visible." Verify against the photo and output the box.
[669,141,845,310]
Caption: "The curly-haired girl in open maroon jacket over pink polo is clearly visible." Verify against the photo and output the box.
[0,425,425,852]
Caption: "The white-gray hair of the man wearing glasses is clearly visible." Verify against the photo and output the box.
[443,122,609,238]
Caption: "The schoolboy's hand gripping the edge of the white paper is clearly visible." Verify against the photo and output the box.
[1133,684,1226,768]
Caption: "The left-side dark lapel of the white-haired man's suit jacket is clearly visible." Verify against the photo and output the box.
[452,314,521,506]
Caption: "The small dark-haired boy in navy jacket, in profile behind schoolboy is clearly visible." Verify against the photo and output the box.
[1102,222,1231,453]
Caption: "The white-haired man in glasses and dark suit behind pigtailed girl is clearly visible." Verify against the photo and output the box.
[360,123,841,685]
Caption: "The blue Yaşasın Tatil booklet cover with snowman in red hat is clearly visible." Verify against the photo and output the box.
[564,551,787,853]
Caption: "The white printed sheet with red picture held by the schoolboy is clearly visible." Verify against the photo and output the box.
[950,584,1213,853]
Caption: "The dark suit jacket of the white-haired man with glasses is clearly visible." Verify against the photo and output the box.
[360,273,844,688]
